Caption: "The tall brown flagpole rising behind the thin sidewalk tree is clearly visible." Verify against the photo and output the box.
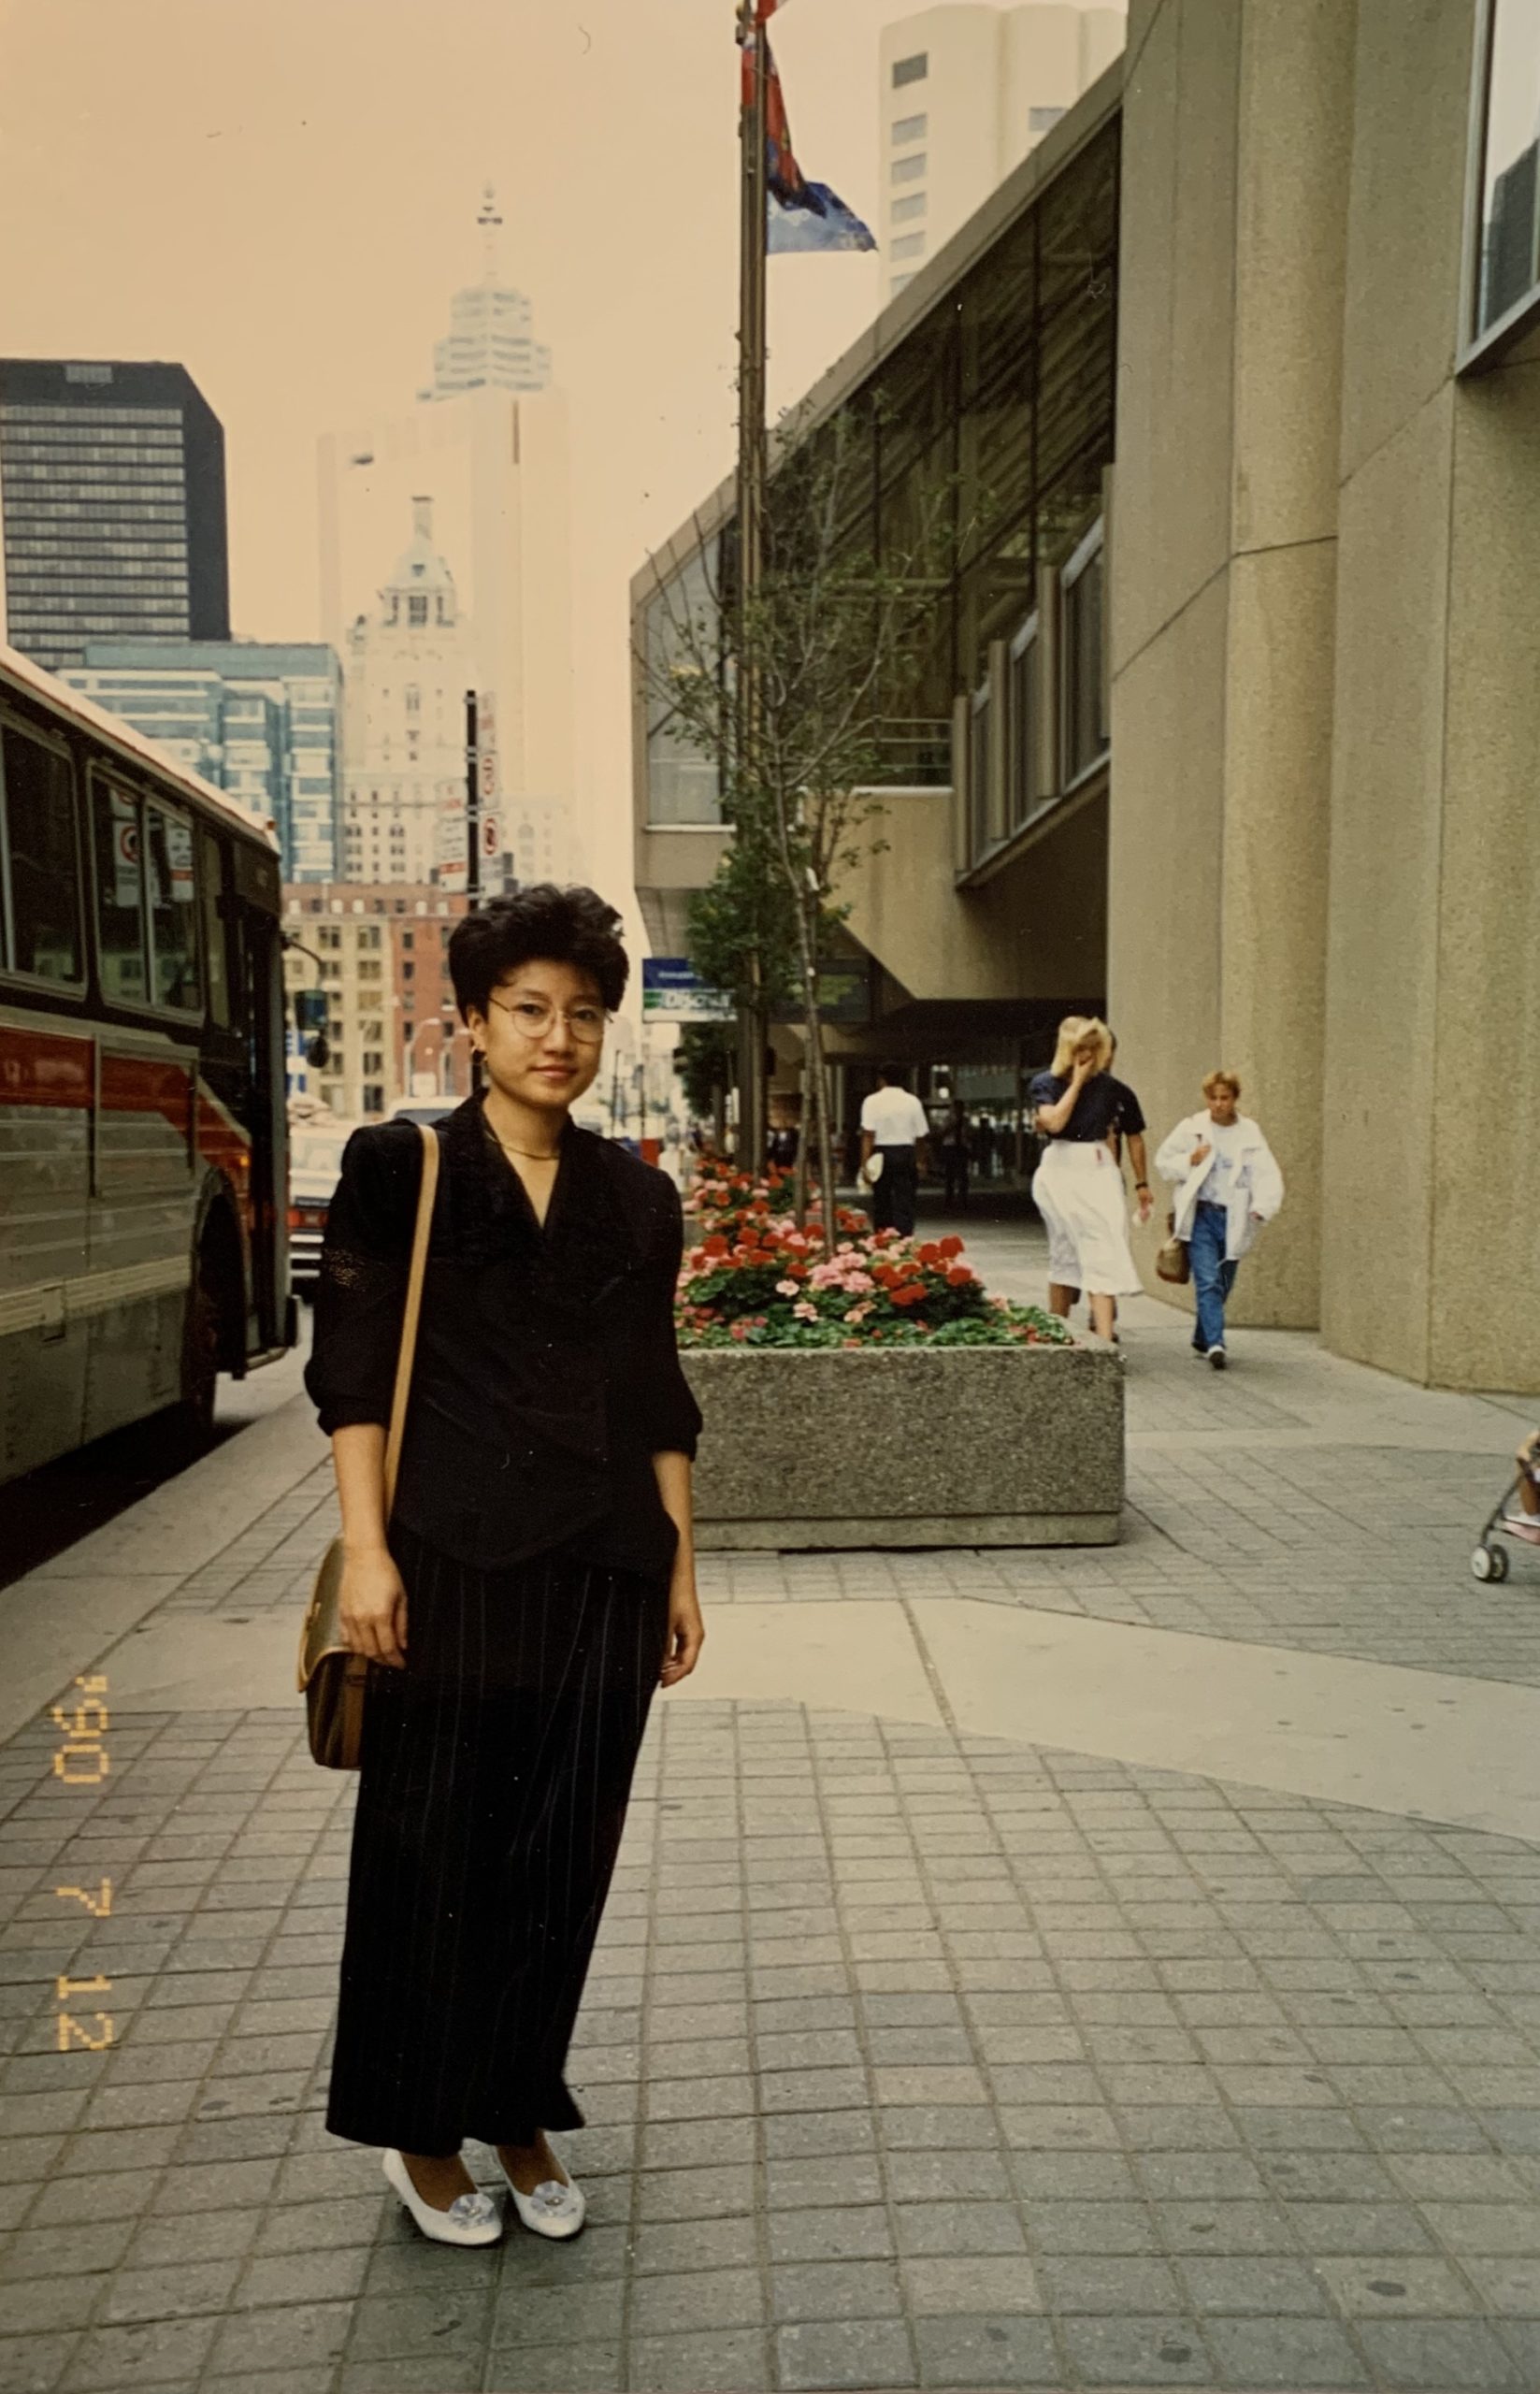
[735,0,769,1171]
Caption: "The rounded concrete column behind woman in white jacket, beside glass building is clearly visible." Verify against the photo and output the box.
[1109,0,1353,1326]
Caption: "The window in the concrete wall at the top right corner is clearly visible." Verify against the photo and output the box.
[1466,0,1540,364]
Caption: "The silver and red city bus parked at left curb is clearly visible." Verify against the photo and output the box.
[0,644,295,1482]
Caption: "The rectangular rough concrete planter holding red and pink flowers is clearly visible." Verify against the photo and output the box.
[683,1341,1123,1549]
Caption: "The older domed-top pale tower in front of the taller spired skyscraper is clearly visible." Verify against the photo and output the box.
[342,496,472,881]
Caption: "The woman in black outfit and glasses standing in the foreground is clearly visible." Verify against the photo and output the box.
[304,884,704,2245]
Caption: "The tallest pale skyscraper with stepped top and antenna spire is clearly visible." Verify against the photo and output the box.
[319,194,572,872]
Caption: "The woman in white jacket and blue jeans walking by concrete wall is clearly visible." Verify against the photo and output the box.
[1155,1073,1284,1372]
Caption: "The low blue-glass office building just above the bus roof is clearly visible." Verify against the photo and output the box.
[63,640,342,881]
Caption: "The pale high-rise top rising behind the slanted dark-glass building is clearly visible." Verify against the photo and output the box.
[879,0,1123,296]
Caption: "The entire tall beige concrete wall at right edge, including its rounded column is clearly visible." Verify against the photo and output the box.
[1109,0,1540,1389]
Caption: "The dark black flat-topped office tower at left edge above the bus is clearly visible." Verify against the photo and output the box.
[0,356,230,672]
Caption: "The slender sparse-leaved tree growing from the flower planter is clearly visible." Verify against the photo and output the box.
[637,410,956,1249]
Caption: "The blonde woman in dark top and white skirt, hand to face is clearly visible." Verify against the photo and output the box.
[1028,1015,1152,1338]
